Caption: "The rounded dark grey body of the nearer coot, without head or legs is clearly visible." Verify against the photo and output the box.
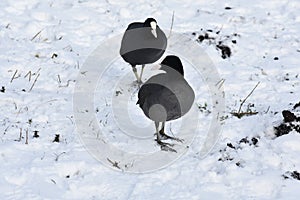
[137,73,195,122]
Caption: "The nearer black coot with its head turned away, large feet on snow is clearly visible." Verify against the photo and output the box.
[137,55,195,151]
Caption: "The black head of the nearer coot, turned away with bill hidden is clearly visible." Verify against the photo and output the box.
[160,55,184,76]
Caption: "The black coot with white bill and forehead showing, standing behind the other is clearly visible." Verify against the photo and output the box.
[120,18,167,83]
